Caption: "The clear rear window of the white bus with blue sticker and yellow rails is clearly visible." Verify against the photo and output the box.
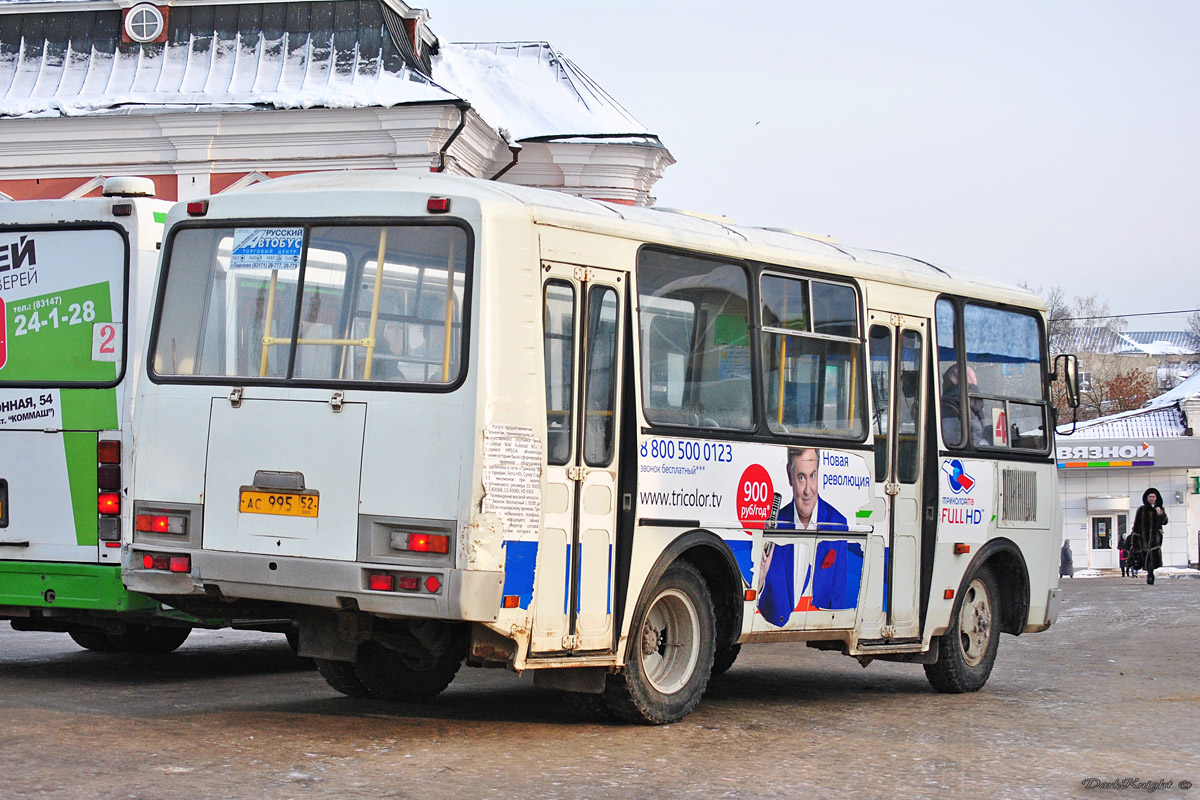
[152,224,469,385]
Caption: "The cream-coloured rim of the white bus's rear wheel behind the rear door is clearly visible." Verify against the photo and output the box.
[641,589,700,694]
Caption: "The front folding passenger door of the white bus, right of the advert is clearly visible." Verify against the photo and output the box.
[869,311,929,640]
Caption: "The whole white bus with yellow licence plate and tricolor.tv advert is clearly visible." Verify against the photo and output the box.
[124,173,1080,723]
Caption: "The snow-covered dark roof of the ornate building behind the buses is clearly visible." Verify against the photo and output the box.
[0,0,662,146]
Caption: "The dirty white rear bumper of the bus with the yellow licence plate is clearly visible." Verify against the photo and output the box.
[125,545,504,622]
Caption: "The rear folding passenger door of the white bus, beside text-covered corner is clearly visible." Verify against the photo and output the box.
[530,263,628,655]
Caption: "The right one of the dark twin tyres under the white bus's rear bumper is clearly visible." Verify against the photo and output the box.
[354,631,467,703]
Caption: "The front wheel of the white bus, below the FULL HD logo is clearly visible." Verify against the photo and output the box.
[925,567,1000,694]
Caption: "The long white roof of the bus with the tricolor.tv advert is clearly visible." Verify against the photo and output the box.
[184,170,1045,309]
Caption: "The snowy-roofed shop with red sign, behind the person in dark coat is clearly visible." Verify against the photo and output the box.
[1056,374,1200,569]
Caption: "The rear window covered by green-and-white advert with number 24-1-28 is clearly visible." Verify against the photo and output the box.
[0,228,128,386]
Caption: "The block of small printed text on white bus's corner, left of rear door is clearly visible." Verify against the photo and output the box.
[482,425,544,542]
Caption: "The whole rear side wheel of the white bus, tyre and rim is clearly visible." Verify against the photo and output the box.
[605,561,716,724]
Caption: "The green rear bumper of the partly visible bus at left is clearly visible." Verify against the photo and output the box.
[0,561,160,618]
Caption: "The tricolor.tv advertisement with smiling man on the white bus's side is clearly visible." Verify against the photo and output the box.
[637,437,872,630]
